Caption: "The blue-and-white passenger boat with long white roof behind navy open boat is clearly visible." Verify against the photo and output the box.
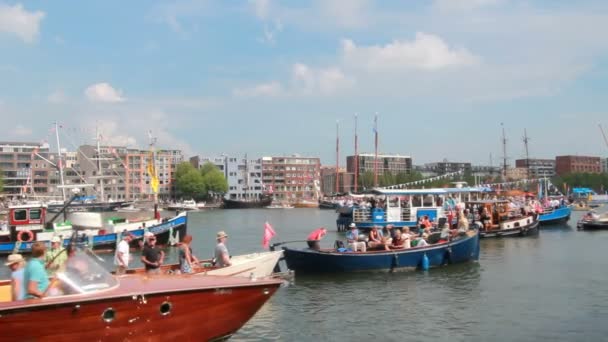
[337,187,491,231]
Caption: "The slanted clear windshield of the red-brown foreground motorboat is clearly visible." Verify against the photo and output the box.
[56,250,118,294]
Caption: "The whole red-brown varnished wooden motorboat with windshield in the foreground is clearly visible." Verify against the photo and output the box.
[0,247,283,341]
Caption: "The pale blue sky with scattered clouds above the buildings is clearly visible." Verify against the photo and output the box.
[0,0,608,165]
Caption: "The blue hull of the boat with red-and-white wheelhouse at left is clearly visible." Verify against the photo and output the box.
[0,215,187,254]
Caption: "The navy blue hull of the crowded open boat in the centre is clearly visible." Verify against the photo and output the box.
[283,232,479,273]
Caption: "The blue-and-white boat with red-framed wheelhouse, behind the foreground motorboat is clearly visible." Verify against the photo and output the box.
[0,202,187,254]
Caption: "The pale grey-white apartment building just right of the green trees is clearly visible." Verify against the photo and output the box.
[190,155,264,200]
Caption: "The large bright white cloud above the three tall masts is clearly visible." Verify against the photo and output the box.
[342,32,479,71]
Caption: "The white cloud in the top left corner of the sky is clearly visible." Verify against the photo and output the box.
[0,3,45,43]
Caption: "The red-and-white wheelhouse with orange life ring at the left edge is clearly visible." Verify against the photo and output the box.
[0,202,47,242]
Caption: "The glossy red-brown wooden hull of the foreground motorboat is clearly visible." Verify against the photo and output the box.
[0,276,280,341]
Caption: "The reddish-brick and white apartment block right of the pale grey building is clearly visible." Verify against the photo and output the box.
[262,155,321,201]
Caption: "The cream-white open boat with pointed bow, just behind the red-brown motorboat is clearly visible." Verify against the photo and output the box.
[127,251,283,278]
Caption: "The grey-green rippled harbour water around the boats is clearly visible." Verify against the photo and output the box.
[2,209,608,341]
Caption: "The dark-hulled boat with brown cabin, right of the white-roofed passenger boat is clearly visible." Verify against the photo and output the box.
[467,200,539,238]
